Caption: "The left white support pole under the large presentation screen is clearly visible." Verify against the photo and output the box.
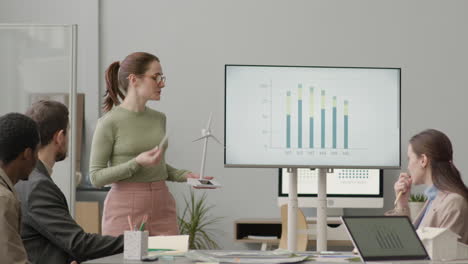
[288,168,296,252]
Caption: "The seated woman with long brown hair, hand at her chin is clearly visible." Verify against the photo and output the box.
[387,129,468,244]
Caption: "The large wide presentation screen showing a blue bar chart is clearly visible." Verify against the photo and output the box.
[224,65,401,169]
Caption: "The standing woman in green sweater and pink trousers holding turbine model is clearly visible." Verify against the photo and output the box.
[90,52,207,236]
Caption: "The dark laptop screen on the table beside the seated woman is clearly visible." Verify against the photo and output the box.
[341,216,430,263]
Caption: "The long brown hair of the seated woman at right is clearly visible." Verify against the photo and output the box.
[410,129,468,202]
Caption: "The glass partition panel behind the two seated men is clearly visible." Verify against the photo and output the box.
[0,24,79,215]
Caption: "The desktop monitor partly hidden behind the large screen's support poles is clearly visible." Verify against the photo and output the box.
[278,168,383,208]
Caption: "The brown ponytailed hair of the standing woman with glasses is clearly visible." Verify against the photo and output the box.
[103,52,160,112]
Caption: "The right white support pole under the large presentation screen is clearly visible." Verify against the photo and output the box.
[317,168,333,253]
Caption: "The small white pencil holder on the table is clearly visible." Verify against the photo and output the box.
[124,231,148,260]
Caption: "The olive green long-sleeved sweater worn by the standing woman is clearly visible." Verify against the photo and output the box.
[90,106,189,187]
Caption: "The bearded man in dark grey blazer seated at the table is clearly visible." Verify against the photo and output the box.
[15,101,123,264]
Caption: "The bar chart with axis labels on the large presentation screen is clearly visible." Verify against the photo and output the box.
[259,76,372,163]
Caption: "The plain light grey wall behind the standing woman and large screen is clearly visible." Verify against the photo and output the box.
[0,0,468,249]
